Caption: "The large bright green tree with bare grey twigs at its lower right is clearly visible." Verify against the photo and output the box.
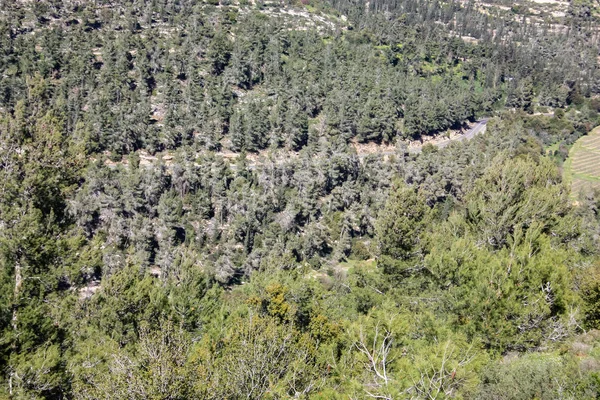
[427,233,576,351]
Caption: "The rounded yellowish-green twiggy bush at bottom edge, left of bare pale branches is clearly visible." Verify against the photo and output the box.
[192,315,322,399]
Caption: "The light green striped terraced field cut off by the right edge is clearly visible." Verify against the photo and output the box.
[564,127,600,195]
